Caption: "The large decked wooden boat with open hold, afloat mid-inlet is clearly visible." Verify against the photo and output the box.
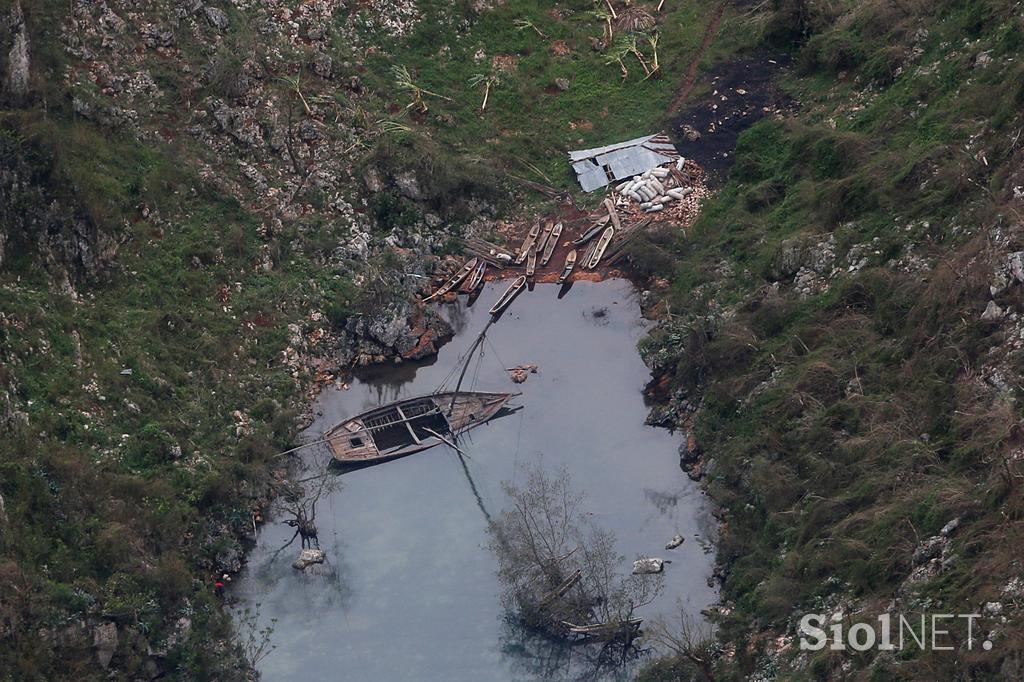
[324,391,519,466]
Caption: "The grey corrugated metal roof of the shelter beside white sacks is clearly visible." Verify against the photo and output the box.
[569,134,679,191]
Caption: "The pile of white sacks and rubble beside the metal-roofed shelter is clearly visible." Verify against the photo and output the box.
[612,159,709,223]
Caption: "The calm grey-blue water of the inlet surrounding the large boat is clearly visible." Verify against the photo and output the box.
[231,280,715,682]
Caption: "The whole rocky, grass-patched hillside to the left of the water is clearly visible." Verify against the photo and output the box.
[0,0,479,680]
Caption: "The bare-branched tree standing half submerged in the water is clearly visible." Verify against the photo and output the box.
[492,467,663,644]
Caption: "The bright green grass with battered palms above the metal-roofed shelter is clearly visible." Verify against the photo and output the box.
[352,0,738,187]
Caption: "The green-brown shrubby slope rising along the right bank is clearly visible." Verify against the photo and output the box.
[634,2,1024,679]
